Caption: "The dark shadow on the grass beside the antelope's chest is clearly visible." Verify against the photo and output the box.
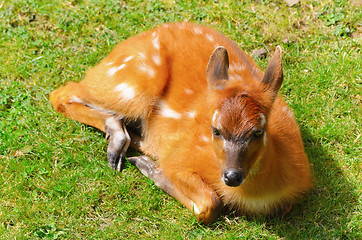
[240,127,361,239]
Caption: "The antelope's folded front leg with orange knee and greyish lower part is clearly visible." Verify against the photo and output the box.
[128,156,221,224]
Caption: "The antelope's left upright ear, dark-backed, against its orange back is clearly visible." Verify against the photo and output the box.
[206,47,229,90]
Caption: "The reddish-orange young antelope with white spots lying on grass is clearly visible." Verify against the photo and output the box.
[50,23,311,224]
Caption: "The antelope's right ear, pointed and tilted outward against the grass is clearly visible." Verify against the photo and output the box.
[261,46,283,98]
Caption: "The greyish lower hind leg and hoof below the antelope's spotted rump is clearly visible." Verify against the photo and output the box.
[105,117,131,171]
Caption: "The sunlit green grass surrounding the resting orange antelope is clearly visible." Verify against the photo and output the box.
[0,0,362,239]
